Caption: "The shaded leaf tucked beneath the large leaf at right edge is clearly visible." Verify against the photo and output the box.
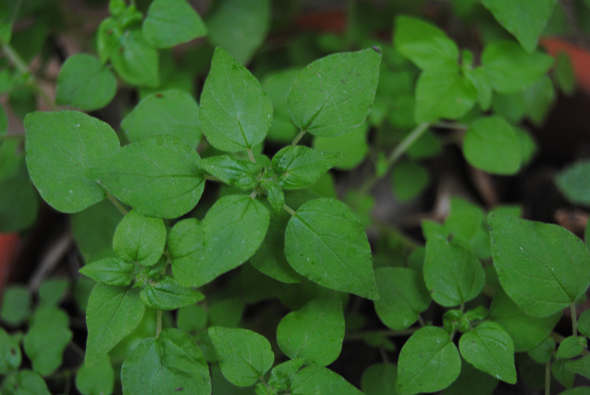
[490,289,562,352]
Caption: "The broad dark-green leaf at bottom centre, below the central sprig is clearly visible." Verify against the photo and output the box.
[277,295,344,366]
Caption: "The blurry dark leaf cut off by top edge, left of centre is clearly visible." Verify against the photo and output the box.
[206,0,271,64]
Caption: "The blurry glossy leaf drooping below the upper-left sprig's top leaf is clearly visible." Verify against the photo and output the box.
[111,29,160,88]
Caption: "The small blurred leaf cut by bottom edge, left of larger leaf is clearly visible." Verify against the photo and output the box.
[76,355,115,395]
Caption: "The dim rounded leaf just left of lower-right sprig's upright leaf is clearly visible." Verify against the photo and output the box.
[375,267,431,330]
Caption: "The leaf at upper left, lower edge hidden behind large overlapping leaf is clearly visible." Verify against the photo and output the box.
[121,90,201,147]
